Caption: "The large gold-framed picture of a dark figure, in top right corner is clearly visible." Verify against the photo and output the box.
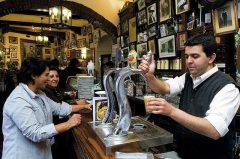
[212,0,238,35]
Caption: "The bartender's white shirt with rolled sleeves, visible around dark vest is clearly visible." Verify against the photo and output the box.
[166,66,240,136]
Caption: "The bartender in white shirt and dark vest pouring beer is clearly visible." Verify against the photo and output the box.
[139,34,240,159]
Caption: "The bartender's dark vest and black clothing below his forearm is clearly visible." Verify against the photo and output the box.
[174,71,235,159]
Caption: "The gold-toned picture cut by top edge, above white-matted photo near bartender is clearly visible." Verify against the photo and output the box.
[159,0,172,22]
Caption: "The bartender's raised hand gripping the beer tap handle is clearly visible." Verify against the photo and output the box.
[138,55,155,76]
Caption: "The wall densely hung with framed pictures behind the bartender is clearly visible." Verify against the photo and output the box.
[118,0,238,76]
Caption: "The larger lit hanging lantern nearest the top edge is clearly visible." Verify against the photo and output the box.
[49,0,72,28]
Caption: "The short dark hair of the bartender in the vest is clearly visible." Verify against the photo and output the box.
[185,34,217,57]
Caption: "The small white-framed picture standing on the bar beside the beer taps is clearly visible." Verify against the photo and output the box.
[93,97,108,123]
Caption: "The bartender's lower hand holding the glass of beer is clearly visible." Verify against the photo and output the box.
[148,98,176,116]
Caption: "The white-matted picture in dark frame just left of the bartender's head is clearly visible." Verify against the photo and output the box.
[158,35,176,58]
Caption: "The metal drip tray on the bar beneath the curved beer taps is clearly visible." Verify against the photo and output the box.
[88,116,173,155]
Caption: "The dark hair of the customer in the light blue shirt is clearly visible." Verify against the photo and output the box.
[17,58,47,84]
